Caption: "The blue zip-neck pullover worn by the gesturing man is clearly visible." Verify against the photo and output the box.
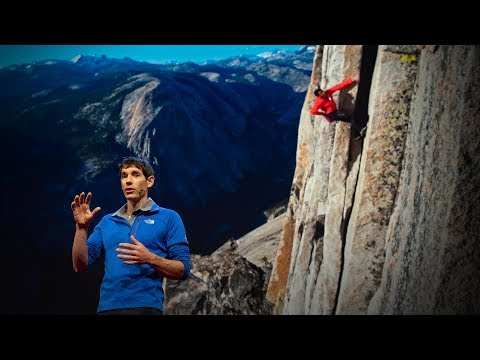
[87,199,190,312]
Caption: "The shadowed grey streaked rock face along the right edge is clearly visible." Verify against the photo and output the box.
[368,45,480,314]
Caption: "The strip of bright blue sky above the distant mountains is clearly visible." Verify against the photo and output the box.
[0,45,300,67]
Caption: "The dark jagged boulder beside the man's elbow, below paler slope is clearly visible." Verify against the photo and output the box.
[164,252,273,315]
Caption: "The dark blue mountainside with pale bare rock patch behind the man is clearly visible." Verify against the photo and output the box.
[0,47,313,313]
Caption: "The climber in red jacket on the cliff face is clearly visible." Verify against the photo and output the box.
[310,79,358,123]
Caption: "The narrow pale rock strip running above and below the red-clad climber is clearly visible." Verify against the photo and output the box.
[281,45,345,314]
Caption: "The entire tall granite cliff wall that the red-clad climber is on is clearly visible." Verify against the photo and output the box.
[267,45,480,314]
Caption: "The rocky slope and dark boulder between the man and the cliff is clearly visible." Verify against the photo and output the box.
[164,214,285,315]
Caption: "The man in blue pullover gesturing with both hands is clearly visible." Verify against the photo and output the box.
[71,157,190,315]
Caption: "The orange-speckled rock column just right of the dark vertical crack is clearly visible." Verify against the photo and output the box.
[337,46,418,314]
